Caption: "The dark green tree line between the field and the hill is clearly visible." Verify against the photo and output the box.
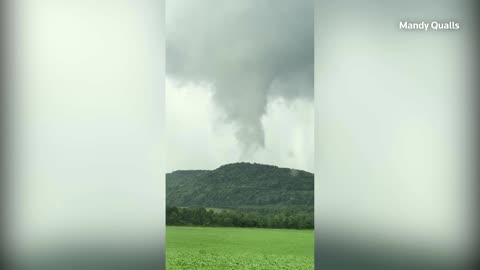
[166,206,314,229]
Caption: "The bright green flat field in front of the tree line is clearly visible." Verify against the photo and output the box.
[167,226,314,270]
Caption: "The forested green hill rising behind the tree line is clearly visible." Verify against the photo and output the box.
[166,163,314,209]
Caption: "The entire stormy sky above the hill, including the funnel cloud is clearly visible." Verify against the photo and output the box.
[166,0,314,171]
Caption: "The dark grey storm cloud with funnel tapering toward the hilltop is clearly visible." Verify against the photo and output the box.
[166,0,314,155]
